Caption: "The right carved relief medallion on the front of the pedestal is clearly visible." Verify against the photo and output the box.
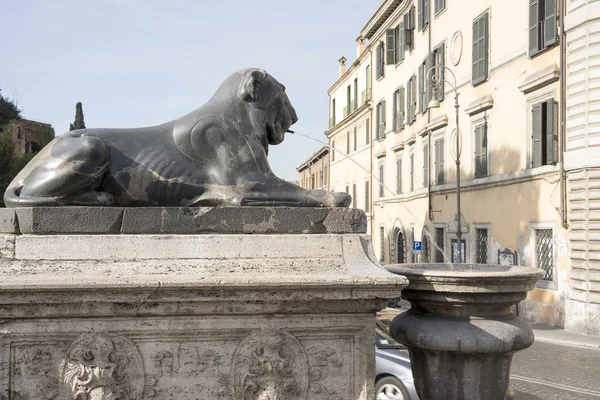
[231,331,309,400]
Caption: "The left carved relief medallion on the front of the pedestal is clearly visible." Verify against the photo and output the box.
[59,334,144,400]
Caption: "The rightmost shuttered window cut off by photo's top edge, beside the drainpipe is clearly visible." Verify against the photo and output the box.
[529,0,558,57]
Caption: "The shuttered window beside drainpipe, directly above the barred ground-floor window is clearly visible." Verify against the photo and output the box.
[531,99,558,168]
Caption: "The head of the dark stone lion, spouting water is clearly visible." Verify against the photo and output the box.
[238,69,298,144]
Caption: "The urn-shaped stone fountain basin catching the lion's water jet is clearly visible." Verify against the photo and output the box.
[388,264,543,400]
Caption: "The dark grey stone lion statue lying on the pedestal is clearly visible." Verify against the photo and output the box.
[4,68,351,207]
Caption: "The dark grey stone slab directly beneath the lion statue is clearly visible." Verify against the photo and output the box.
[0,207,367,235]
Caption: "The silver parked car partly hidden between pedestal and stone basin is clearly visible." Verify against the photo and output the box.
[375,320,419,400]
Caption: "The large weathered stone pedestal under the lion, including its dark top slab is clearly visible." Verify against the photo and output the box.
[0,207,407,400]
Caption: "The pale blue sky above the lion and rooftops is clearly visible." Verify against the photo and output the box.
[0,0,379,180]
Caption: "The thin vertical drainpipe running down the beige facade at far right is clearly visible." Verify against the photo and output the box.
[558,0,569,229]
